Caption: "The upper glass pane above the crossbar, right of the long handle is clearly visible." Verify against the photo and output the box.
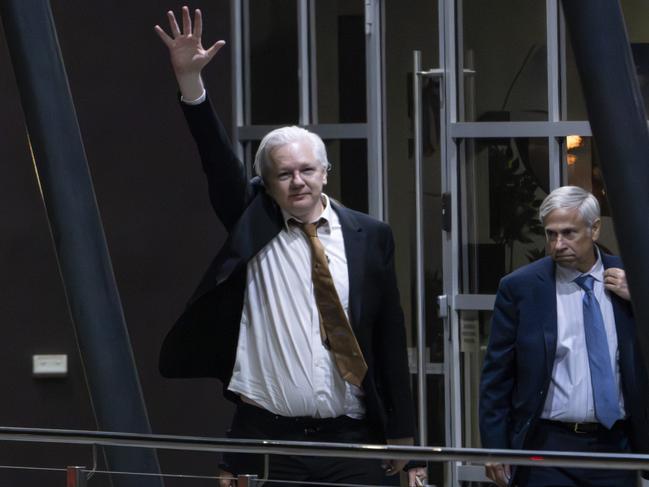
[458,0,548,122]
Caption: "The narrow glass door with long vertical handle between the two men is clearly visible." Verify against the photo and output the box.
[382,0,453,487]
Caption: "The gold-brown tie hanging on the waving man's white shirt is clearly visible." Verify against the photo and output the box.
[298,220,367,387]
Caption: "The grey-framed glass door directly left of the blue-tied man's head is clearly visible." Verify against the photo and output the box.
[447,0,560,486]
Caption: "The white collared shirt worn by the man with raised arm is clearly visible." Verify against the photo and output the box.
[228,195,365,418]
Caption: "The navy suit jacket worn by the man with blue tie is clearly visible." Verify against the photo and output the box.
[480,253,649,453]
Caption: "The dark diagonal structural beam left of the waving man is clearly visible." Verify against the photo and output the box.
[0,0,163,487]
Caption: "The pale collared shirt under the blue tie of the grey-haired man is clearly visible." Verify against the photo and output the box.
[541,249,624,422]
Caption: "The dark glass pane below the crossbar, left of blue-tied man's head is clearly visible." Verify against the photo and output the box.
[460,138,549,294]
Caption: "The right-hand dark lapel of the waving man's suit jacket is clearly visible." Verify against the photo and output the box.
[330,200,366,331]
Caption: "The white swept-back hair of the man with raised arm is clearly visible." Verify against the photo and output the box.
[254,125,330,178]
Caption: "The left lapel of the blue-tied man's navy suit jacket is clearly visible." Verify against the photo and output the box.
[534,257,557,377]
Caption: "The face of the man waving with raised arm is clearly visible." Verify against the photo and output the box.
[265,139,327,221]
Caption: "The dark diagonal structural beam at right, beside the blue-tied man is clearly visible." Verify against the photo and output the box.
[562,0,649,369]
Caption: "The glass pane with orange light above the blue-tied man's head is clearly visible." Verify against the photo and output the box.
[565,135,620,255]
